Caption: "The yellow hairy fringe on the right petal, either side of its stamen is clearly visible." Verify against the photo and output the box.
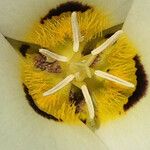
[93,35,137,123]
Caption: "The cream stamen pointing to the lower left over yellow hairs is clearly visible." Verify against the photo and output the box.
[43,74,75,96]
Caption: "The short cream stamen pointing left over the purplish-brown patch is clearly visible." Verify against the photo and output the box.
[39,49,68,62]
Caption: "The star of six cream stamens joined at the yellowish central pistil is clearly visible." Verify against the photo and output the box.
[39,12,134,122]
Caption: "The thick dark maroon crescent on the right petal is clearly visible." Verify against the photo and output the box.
[124,56,148,110]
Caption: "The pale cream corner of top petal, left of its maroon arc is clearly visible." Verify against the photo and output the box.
[0,0,65,40]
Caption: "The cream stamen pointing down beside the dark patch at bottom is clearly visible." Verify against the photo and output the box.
[81,85,95,120]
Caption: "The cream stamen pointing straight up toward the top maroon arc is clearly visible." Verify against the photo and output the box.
[71,12,81,52]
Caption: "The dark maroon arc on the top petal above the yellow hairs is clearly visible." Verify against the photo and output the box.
[40,1,91,24]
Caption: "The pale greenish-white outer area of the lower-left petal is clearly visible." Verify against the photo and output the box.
[0,34,106,150]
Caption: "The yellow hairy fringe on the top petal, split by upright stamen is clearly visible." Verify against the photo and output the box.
[27,9,110,52]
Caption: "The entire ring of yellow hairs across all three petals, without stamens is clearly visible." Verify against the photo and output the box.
[22,9,136,123]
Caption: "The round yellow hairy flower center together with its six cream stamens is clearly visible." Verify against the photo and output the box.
[21,1,137,126]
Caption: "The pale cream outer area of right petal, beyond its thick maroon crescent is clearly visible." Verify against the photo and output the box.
[98,0,150,150]
